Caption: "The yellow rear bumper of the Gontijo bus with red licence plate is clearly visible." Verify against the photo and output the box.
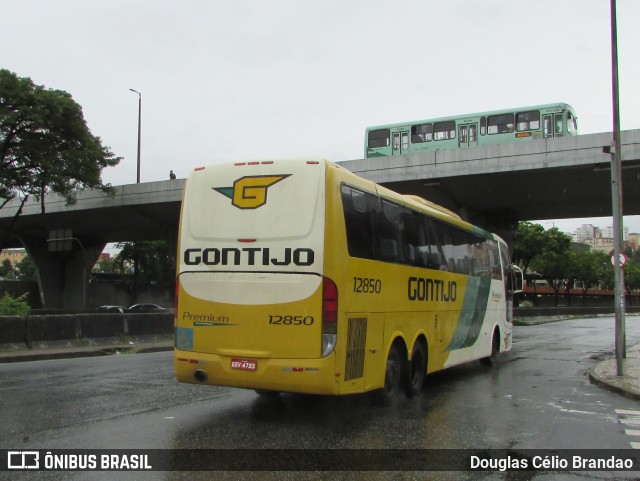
[174,349,340,395]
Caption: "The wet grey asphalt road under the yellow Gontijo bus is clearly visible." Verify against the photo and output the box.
[0,317,640,481]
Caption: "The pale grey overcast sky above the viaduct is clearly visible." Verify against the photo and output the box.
[0,0,640,232]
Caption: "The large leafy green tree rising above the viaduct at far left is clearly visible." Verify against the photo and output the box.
[0,69,120,232]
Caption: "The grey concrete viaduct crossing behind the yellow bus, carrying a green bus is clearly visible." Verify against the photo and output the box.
[0,130,640,308]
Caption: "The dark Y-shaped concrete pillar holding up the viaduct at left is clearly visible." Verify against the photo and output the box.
[23,239,106,309]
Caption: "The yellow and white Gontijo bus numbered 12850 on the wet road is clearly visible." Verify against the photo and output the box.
[174,159,513,402]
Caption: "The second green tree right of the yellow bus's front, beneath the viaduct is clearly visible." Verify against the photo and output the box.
[531,227,574,306]
